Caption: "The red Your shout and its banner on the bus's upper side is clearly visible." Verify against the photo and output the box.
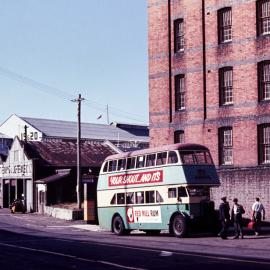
[108,170,163,186]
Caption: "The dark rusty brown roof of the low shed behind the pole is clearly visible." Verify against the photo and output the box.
[21,141,116,167]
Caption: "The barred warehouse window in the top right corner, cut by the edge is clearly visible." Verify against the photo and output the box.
[257,0,270,35]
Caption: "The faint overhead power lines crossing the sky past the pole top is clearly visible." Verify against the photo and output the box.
[0,66,149,123]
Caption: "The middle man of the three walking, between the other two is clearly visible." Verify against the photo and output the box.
[231,198,245,239]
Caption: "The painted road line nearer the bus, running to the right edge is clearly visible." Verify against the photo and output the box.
[58,239,270,265]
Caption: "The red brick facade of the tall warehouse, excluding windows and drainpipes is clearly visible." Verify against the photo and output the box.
[148,0,270,216]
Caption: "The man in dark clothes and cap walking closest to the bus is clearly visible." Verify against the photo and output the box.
[218,197,230,239]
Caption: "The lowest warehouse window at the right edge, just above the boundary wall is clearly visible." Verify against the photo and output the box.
[258,124,270,164]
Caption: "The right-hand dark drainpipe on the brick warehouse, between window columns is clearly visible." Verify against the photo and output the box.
[202,0,207,120]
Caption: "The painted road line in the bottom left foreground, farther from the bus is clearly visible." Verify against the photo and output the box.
[0,242,147,270]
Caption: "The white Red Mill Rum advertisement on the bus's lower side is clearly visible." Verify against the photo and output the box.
[127,206,161,223]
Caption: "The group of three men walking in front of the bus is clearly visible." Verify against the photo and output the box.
[218,197,265,239]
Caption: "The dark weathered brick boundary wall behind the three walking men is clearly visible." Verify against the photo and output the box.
[211,167,270,221]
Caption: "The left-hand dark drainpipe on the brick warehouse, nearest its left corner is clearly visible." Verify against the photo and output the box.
[168,0,172,123]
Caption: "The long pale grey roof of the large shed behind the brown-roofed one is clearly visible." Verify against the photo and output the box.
[21,117,149,142]
